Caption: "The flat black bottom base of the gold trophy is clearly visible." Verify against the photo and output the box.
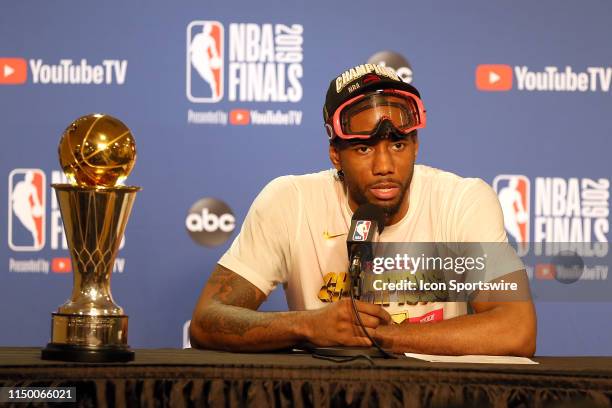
[41,343,134,363]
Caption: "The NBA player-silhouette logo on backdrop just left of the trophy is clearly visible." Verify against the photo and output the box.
[8,169,46,251]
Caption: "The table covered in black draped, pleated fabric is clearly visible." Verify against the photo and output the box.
[0,348,612,407]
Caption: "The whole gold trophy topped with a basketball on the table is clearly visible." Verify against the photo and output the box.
[42,114,140,362]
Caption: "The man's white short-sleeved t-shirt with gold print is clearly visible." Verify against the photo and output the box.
[219,165,520,322]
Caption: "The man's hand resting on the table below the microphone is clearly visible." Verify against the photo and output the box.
[305,298,391,347]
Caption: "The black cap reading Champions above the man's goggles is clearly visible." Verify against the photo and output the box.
[323,64,421,123]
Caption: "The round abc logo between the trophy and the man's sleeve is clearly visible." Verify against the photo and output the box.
[185,197,236,246]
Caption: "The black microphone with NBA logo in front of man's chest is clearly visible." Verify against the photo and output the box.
[346,203,385,300]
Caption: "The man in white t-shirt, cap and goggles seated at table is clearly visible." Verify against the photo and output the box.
[190,64,536,356]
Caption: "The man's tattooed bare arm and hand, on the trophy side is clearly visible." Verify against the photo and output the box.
[190,265,391,352]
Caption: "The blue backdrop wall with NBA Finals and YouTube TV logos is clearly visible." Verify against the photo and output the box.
[0,0,612,355]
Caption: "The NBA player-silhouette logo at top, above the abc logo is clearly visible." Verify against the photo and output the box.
[187,21,224,103]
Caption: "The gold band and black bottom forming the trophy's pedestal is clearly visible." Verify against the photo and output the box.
[42,313,134,363]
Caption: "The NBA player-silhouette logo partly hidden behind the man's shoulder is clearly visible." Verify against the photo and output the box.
[493,174,530,255]
